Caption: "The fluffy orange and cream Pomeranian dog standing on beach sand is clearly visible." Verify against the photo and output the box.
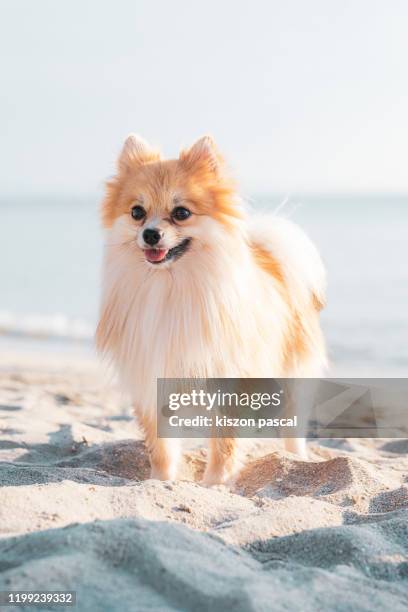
[96,134,326,485]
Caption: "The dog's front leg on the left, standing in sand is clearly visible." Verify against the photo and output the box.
[136,411,180,480]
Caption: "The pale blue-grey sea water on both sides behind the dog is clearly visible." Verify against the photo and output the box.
[0,195,408,377]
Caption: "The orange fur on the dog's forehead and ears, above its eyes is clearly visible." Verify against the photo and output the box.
[102,135,242,228]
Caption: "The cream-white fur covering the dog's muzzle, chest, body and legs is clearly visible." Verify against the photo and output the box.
[97,134,326,484]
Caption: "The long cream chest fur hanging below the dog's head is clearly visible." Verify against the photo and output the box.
[98,241,285,409]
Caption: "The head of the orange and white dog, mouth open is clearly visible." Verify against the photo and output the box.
[102,134,242,268]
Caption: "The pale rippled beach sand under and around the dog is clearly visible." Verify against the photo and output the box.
[0,354,408,612]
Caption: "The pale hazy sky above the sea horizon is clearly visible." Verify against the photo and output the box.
[0,0,408,195]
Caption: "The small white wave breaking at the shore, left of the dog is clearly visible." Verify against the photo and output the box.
[0,311,95,342]
